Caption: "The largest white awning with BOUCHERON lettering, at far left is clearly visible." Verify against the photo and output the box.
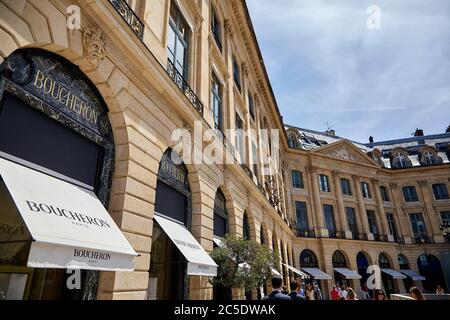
[0,158,137,271]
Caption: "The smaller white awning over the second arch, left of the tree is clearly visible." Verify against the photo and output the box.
[154,214,217,277]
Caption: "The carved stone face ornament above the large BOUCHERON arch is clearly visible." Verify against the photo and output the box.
[83,27,106,67]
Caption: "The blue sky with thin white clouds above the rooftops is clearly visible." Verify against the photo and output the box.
[247,0,450,142]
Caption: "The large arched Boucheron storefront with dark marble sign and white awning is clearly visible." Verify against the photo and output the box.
[0,49,136,299]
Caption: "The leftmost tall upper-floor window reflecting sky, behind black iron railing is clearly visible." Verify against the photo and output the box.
[167,1,189,80]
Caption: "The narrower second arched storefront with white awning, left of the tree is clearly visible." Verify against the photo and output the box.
[147,149,217,300]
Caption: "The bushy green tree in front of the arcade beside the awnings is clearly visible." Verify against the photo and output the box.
[210,236,278,291]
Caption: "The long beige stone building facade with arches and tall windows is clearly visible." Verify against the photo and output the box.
[0,0,450,300]
